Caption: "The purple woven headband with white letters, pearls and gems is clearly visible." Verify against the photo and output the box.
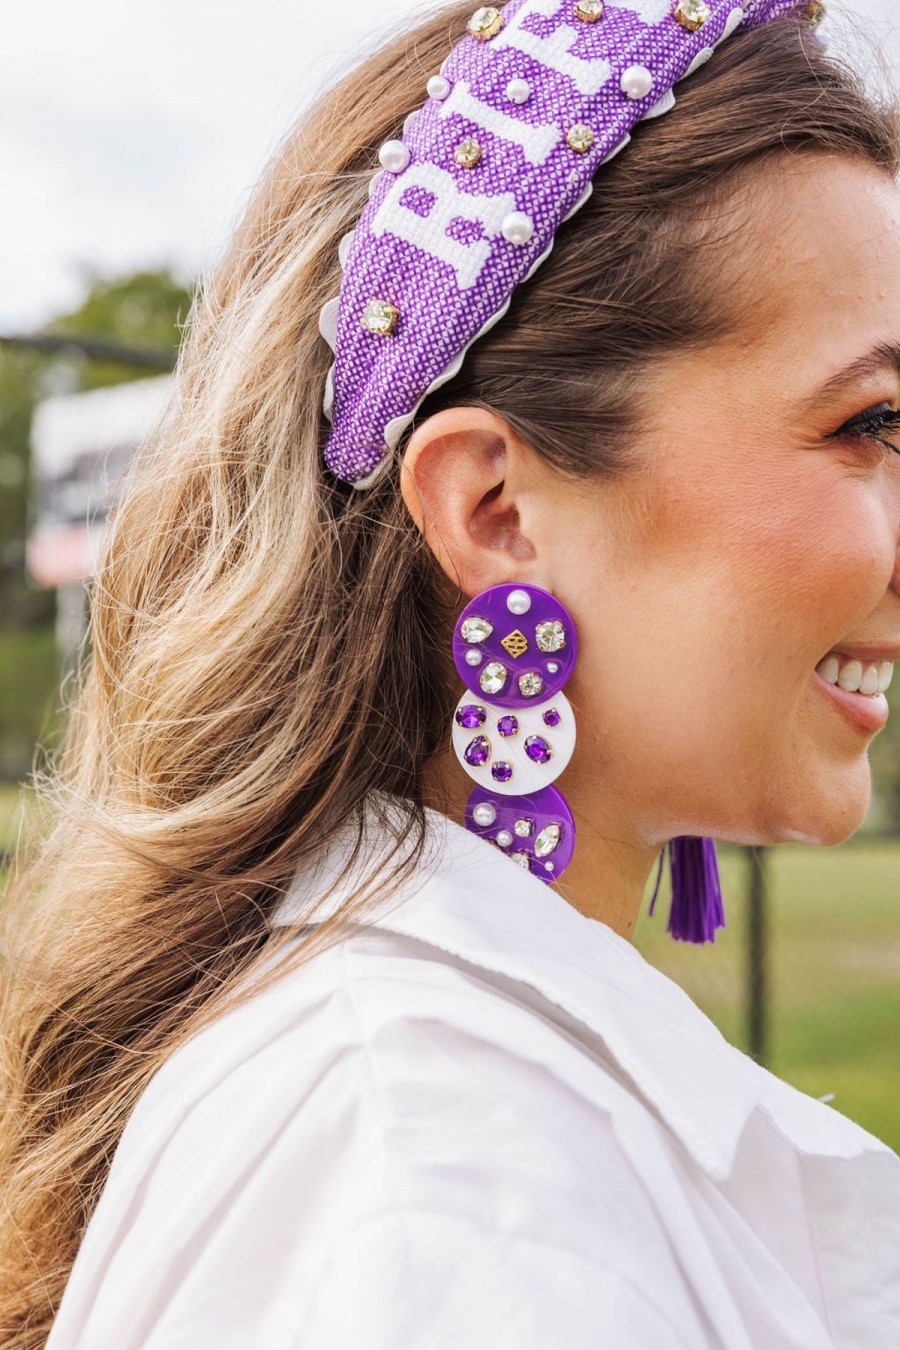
[318,0,824,487]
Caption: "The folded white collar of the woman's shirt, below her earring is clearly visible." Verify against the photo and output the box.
[271,798,892,1180]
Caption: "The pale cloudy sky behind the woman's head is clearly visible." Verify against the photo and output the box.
[0,0,900,333]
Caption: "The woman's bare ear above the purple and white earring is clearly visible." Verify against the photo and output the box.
[401,396,542,597]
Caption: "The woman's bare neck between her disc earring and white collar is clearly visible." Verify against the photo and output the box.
[422,748,661,941]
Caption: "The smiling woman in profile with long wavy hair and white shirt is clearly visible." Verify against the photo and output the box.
[0,0,900,1350]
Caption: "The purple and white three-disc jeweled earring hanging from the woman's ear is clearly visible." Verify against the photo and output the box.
[452,583,578,882]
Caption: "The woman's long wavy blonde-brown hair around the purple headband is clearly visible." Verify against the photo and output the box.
[0,0,900,1350]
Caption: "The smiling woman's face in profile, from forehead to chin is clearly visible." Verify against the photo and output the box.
[555,155,900,844]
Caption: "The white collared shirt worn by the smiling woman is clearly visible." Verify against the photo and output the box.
[47,793,900,1350]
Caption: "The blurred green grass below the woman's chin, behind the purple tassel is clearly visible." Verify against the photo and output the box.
[634,840,900,1152]
